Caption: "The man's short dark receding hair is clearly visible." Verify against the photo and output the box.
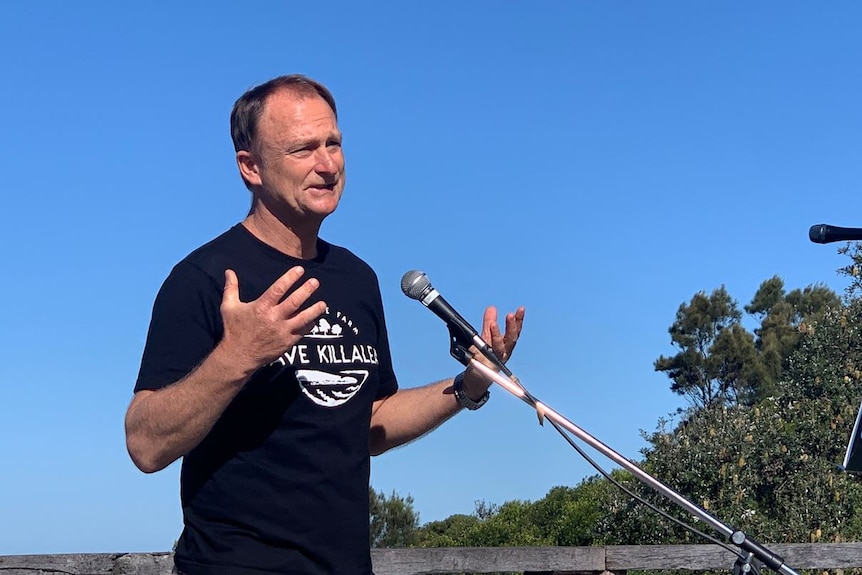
[230,74,338,152]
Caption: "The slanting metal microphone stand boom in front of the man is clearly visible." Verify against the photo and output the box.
[449,336,799,575]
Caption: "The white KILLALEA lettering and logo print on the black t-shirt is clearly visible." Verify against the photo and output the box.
[271,308,378,407]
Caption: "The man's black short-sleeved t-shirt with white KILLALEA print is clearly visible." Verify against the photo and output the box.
[135,225,397,575]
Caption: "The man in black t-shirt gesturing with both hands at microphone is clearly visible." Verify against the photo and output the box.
[126,75,524,575]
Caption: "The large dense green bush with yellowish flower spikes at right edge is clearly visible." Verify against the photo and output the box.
[597,294,862,544]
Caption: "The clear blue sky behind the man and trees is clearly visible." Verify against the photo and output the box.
[0,0,862,554]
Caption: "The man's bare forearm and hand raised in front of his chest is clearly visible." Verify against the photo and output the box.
[126,267,326,473]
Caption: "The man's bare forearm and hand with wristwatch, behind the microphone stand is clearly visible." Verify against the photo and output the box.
[369,307,524,455]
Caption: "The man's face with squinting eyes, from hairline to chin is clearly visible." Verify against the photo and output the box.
[237,90,345,224]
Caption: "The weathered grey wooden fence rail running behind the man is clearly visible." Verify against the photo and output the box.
[0,543,862,575]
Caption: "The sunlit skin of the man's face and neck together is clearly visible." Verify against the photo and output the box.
[236,90,345,259]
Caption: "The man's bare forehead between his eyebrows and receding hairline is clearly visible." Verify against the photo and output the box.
[258,90,338,143]
